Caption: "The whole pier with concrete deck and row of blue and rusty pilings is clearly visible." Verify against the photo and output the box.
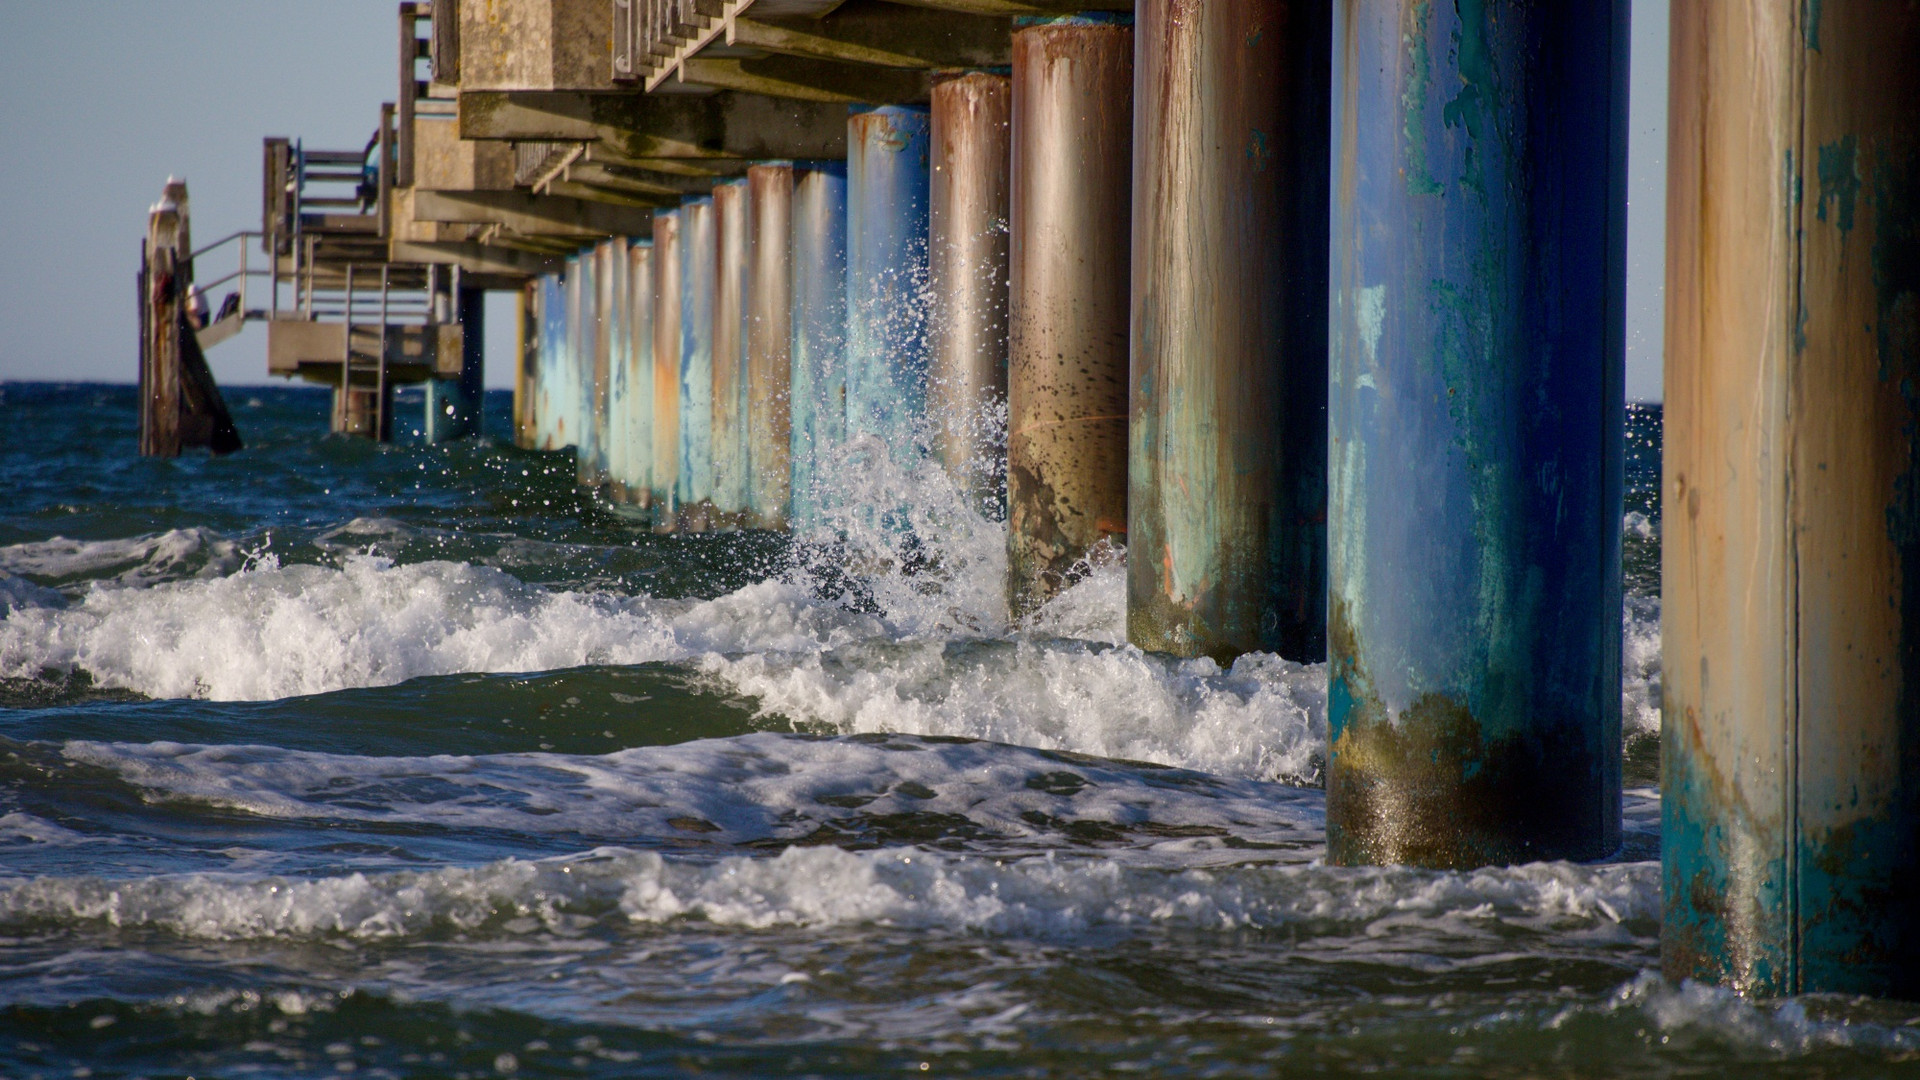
[140,0,1920,995]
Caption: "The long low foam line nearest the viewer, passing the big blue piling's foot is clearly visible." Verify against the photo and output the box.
[0,847,1659,944]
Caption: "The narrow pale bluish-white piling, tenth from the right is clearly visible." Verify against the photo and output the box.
[678,196,718,532]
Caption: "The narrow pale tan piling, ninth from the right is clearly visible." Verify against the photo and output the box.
[712,179,753,528]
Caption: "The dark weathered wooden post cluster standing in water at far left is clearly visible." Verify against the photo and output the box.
[138,177,240,457]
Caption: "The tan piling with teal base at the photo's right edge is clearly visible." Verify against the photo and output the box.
[1661,0,1920,999]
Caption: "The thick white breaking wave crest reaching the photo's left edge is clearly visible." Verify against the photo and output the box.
[0,555,877,700]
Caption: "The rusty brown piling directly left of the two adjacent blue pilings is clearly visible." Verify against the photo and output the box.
[747,161,793,528]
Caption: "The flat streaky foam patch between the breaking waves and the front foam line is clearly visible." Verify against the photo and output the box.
[63,732,1323,853]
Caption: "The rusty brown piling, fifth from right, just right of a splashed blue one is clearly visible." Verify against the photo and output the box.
[927,71,1013,515]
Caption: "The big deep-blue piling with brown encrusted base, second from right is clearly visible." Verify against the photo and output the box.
[1327,0,1628,867]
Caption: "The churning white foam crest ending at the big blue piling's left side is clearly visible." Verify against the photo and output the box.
[701,640,1327,778]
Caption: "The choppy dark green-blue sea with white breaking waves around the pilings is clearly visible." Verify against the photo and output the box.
[0,384,1920,1078]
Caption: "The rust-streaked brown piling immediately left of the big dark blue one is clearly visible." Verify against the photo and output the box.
[1127,0,1328,663]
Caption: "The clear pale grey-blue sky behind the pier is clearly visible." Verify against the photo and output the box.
[0,0,1667,402]
